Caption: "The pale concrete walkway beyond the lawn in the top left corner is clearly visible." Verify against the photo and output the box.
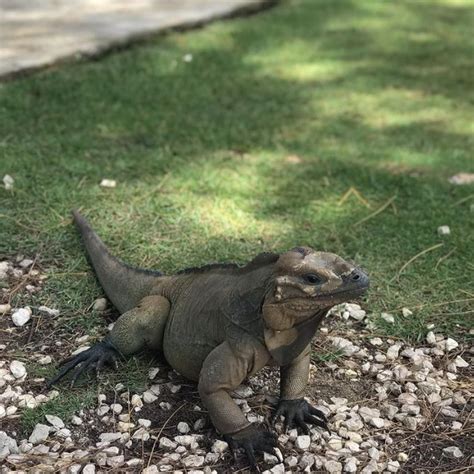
[0,0,267,76]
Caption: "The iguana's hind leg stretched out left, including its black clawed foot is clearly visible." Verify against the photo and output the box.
[47,296,170,387]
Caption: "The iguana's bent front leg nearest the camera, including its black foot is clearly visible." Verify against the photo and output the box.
[198,341,277,467]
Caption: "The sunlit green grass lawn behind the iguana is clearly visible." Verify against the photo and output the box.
[0,0,474,352]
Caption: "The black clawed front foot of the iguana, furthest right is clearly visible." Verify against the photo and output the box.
[273,398,329,434]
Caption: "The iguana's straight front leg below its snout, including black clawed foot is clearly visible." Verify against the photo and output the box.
[273,344,329,433]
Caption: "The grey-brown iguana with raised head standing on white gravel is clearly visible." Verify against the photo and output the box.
[49,211,369,467]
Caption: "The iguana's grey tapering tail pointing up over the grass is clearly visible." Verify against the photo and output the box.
[72,211,161,313]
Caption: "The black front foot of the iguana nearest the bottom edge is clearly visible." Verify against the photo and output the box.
[224,426,278,472]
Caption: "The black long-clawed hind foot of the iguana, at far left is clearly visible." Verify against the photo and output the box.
[46,341,118,388]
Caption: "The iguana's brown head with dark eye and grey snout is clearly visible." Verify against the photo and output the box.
[262,247,369,331]
